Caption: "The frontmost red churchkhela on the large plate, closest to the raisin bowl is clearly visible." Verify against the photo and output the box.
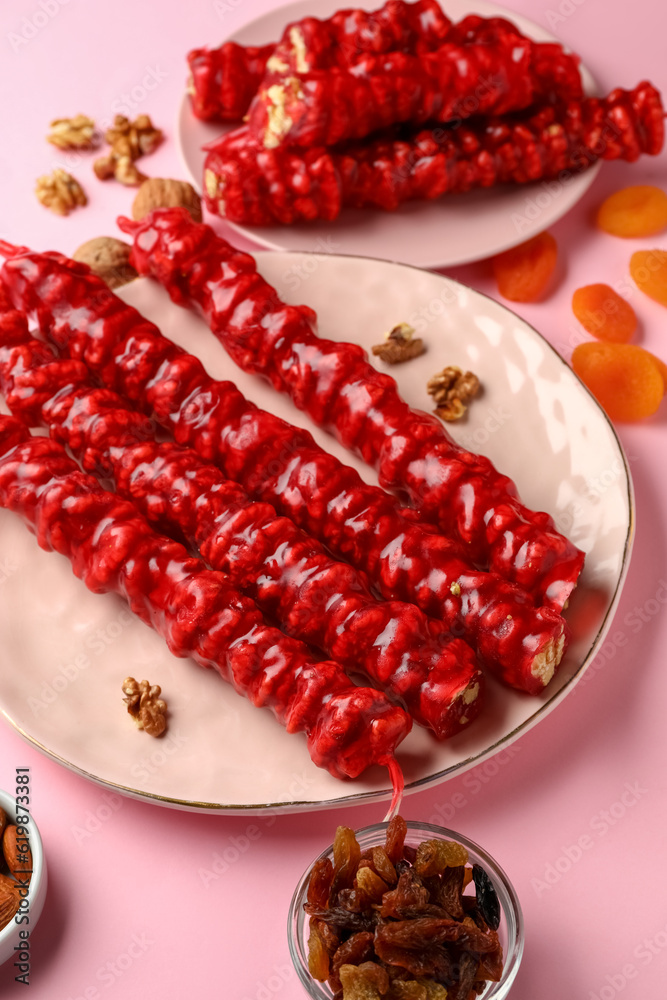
[0,415,411,778]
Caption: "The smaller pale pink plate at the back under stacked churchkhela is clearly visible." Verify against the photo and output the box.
[176,0,599,267]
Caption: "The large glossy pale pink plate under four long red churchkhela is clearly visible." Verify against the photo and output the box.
[0,252,633,812]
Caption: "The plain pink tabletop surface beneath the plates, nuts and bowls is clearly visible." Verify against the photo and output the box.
[0,0,667,1000]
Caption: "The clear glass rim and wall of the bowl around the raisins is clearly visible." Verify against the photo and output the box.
[287,820,524,1000]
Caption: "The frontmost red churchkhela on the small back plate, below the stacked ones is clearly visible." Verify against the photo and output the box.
[204,82,664,226]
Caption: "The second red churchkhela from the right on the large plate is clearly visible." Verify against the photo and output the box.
[0,245,567,693]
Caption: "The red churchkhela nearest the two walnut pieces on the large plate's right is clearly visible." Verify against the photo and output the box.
[118,209,584,613]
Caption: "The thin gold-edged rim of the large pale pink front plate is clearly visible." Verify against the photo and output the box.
[0,250,636,815]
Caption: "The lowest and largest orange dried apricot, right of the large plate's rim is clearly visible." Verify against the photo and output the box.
[572,341,664,422]
